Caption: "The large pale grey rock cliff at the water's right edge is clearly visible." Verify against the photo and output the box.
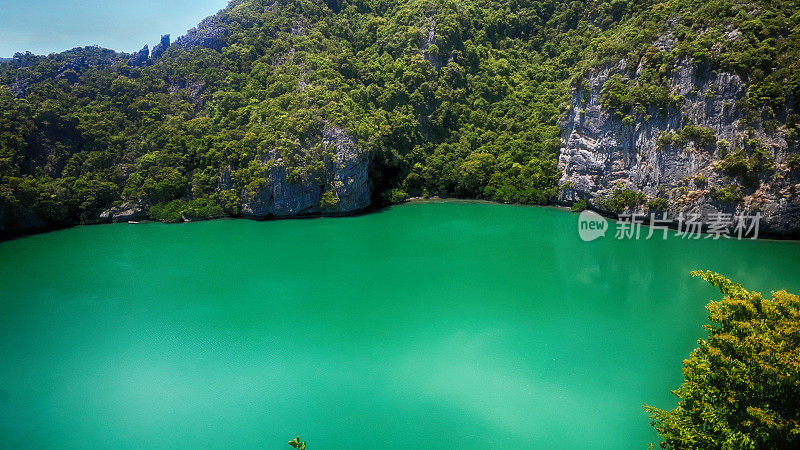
[558,42,800,236]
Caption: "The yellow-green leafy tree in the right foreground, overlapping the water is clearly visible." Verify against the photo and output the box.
[645,272,800,449]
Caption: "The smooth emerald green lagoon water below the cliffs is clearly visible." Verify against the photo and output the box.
[0,202,800,449]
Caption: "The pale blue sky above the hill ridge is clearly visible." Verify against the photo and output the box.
[0,0,228,58]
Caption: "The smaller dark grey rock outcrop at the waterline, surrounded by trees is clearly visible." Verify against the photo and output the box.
[241,127,371,218]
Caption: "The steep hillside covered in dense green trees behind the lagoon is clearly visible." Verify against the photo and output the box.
[0,0,800,231]
